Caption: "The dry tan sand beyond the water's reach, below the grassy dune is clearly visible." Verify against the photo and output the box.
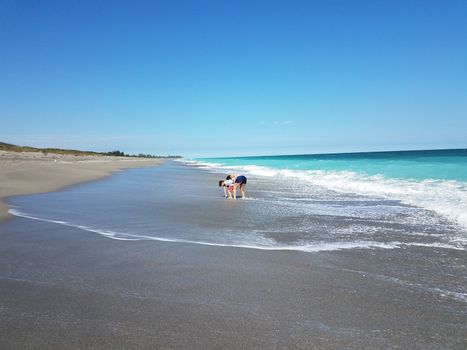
[0,151,163,222]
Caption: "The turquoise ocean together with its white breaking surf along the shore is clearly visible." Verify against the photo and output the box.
[192,149,467,230]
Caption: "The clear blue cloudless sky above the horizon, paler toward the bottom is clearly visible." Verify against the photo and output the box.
[0,0,467,157]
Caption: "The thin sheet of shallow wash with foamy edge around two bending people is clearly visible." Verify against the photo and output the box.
[9,162,467,304]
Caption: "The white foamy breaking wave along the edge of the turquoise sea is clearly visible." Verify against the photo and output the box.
[184,162,467,235]
